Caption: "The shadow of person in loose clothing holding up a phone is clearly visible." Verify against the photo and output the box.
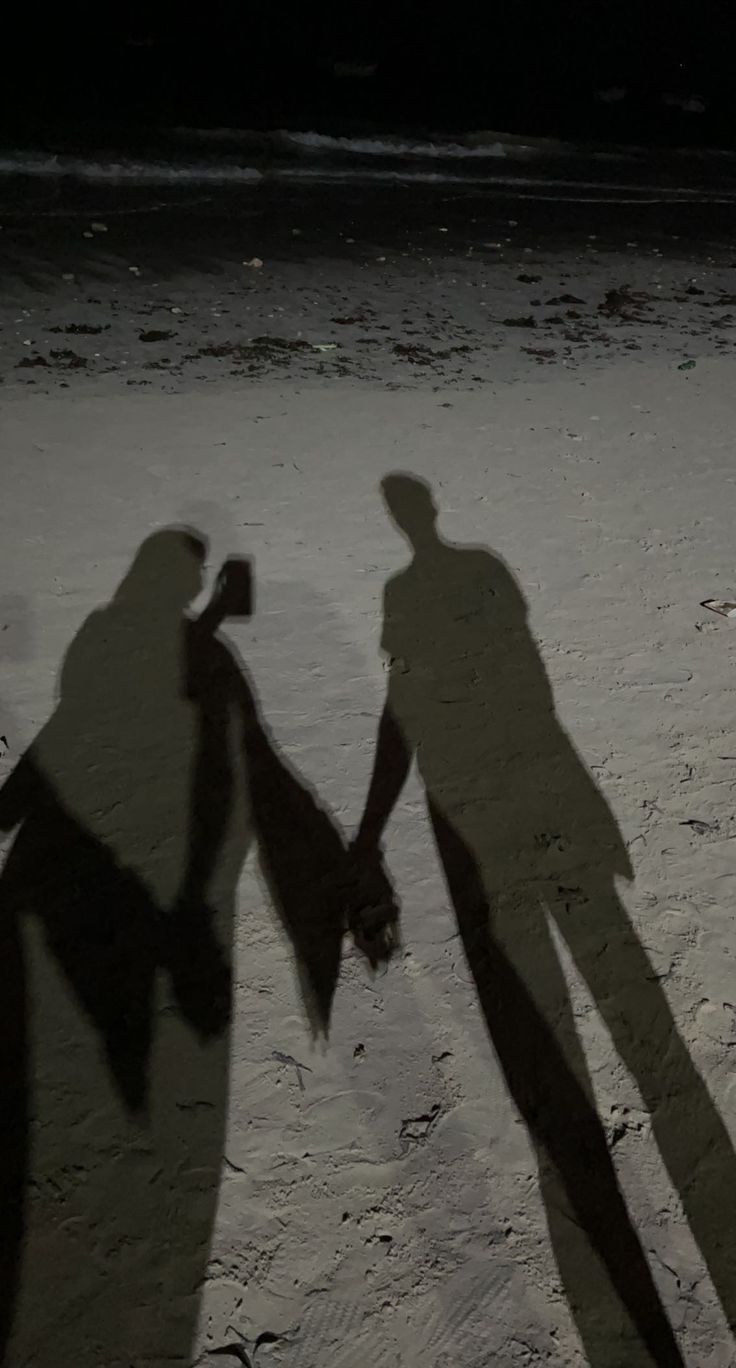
[0,527,377,1368]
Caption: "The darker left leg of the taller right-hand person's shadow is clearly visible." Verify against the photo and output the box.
[430,806,683,1368]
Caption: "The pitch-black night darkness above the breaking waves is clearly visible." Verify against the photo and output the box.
[3,0,736,141]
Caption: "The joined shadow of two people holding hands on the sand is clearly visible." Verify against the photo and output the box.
[0,476,736,1368]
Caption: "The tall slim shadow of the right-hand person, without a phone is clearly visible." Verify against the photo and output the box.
[348,473,736,1368]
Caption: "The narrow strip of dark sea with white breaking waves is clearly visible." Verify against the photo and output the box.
[0,127,736,213]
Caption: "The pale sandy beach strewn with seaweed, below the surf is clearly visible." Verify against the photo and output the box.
[0,195,736,1368]
